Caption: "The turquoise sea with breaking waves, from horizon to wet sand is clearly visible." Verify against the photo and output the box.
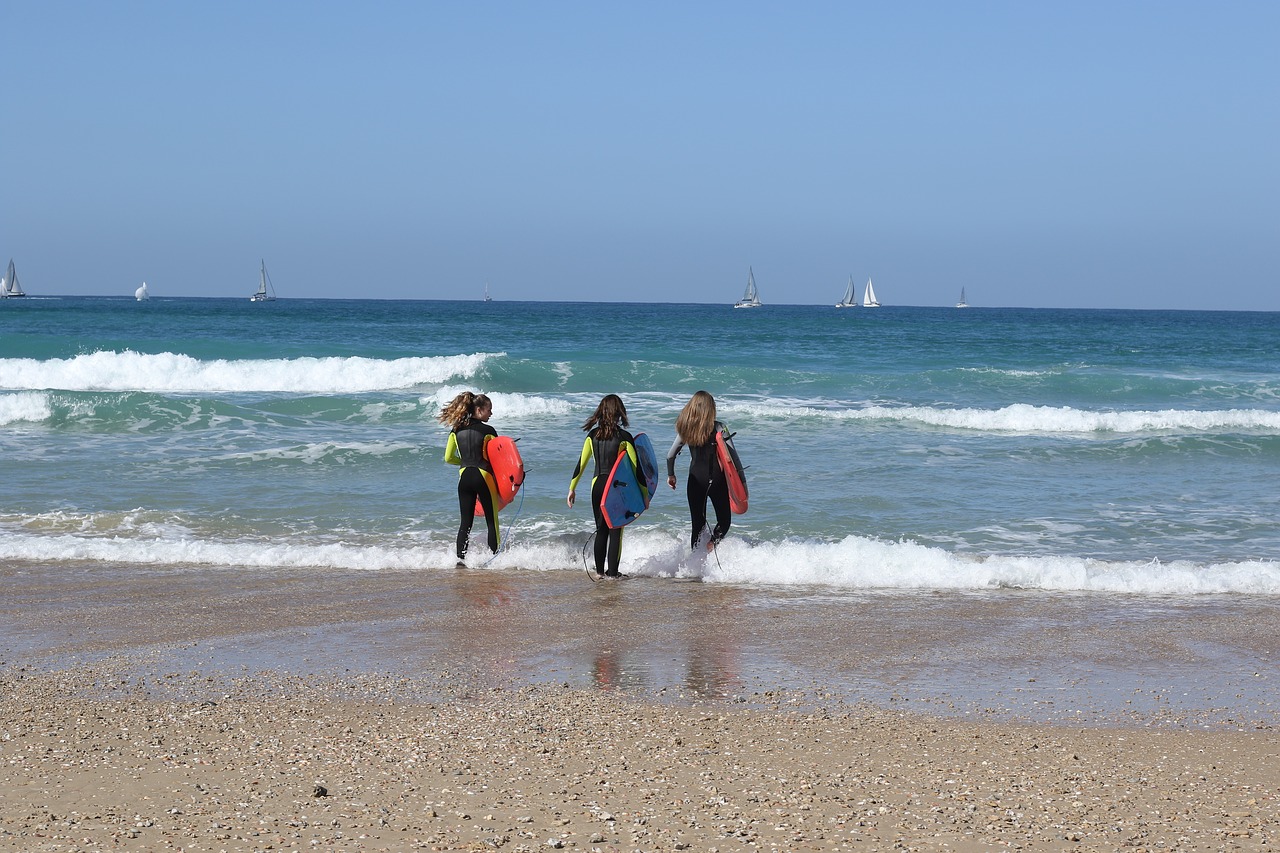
[0,297,1280,596]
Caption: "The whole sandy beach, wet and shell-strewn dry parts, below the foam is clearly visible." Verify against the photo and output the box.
[0,565,1280,850]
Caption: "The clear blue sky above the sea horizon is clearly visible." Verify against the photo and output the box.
[0,0,1280,310]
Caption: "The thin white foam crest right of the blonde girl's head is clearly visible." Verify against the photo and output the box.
[721,402,1280,434]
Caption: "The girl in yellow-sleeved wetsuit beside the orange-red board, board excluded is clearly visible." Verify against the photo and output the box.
[439,391,498,565]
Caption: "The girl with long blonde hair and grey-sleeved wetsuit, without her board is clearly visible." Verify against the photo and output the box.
[667,391,731,551]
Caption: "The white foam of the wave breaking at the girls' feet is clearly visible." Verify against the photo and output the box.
[0,522,1280,596]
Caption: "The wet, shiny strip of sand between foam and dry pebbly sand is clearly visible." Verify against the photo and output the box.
[0,564,1280,730]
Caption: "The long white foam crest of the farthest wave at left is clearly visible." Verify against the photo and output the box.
[0,351,504,394]
